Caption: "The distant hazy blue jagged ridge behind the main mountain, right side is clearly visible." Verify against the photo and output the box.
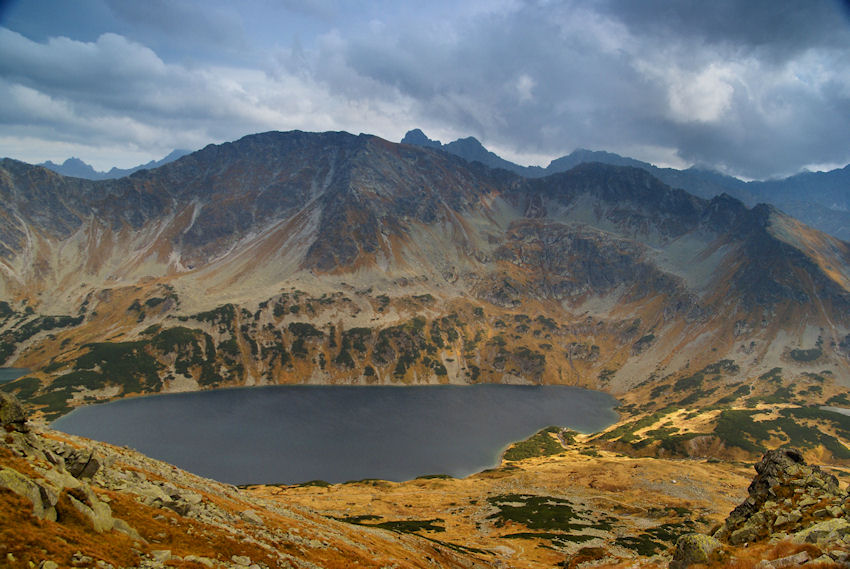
[402,129,850,241]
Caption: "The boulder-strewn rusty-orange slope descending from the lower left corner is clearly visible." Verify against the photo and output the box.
[0,394,487,569]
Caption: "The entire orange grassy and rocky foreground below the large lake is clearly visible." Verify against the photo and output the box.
[0,395,850,569]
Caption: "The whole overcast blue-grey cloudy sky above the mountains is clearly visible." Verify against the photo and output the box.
[0,0,850,178]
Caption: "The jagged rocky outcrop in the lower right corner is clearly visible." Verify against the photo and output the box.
[670,448,850,569]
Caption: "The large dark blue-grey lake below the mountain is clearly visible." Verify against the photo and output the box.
[53,385,617,484]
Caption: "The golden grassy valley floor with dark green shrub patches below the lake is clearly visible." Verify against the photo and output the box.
[247,449,752,569]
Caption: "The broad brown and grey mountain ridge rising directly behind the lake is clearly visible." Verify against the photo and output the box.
[0,131,850,422]
